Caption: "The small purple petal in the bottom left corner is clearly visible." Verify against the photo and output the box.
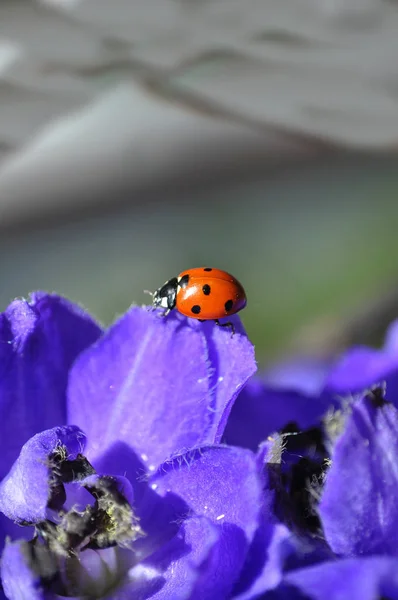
[1,541,55,600]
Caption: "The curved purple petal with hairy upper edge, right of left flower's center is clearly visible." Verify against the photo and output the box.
[151,446,266,598]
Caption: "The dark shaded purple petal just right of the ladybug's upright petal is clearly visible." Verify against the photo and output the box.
[224,379,330,451]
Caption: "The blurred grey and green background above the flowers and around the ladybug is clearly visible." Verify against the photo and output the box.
[0,0,398,364]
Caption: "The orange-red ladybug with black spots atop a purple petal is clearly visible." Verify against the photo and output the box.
[152,267,246,333]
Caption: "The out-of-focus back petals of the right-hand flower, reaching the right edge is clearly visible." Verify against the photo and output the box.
[224,320,398,450]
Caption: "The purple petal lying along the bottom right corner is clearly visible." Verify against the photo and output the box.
[282,557,398,600]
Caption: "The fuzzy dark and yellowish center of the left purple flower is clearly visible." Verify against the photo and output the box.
[24,446,143,598]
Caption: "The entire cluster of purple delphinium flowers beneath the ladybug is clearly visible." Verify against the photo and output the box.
[0,293,398,600]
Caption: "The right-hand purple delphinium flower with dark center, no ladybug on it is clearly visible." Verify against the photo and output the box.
[225,321,398,600]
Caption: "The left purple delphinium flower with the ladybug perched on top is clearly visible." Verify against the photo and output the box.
[0,294,279,600]
